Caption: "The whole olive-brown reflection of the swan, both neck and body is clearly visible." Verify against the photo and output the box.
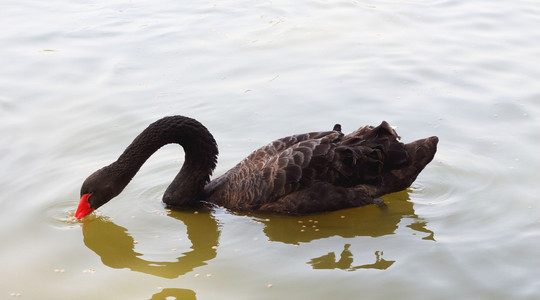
[83,191,435,286]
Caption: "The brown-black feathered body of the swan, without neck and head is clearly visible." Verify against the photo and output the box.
[203,122,437,213]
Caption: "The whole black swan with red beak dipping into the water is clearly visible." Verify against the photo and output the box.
[75,116,439,219]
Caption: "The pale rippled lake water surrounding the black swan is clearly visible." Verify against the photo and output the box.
[0,0,540,300]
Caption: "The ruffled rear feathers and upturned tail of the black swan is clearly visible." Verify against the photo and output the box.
[334,122,438,197]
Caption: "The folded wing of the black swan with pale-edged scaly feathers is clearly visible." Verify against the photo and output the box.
[255,122,408,199]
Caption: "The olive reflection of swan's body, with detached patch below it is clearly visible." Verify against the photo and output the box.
[251,191,435,271]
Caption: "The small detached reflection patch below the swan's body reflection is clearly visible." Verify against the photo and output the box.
[308,244,396,271]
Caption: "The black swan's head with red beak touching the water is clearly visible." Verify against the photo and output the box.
[75,166,129,219]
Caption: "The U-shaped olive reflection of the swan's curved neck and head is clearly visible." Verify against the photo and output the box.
[83,206,219,278]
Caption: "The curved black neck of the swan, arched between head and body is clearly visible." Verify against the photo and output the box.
[111,116,218,206]
